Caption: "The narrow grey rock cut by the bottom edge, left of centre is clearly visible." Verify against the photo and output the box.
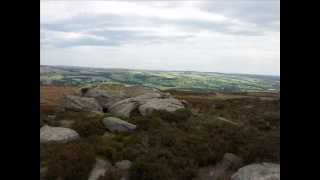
[88,159,112,180]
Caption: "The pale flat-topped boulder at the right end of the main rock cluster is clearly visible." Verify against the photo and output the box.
[139,98,184,116]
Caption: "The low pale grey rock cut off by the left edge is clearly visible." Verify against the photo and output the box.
[40,125,79,143]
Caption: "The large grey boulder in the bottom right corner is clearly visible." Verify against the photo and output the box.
[231,163,280,180]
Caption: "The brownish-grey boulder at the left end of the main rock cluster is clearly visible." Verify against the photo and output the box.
[62,95,102,112]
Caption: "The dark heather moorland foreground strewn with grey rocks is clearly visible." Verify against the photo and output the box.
[40,85,280,180]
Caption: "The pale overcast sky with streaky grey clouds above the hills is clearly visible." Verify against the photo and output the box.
[40,0,280,75]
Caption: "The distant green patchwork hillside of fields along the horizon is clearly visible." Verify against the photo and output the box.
[40,65,280,92]
